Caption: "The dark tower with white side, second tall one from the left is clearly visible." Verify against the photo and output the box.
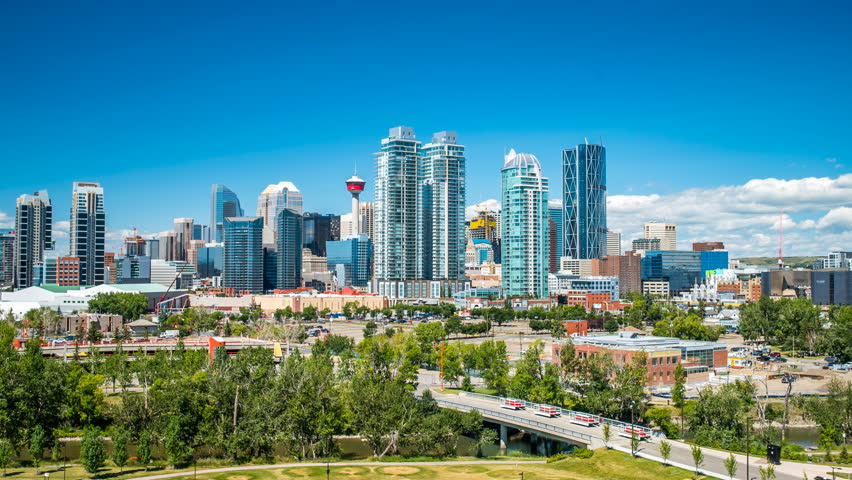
[70,182,106,285]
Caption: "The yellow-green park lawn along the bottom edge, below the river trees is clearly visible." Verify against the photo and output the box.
[0,449,704,480]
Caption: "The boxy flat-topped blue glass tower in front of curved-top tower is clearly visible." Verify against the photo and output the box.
[222,217,263,292]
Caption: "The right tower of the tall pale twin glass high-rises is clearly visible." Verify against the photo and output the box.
[417,131,466,280]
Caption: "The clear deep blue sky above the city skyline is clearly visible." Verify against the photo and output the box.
[0,1,852,253]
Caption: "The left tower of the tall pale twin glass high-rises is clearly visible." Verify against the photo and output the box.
[375,127,420,280]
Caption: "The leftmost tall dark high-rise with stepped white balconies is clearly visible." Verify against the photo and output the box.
[14,190,53,288]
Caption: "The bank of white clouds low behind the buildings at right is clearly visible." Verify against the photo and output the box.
[607,174,852,256]
